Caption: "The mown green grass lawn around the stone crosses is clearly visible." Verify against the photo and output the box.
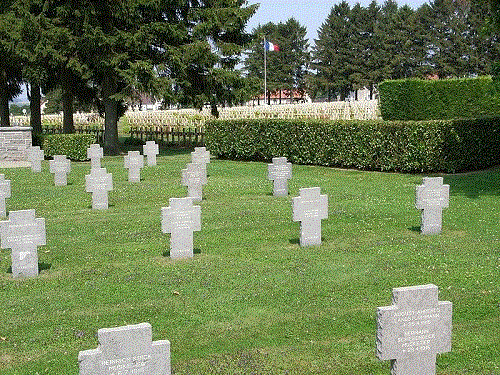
[0,151,500,375]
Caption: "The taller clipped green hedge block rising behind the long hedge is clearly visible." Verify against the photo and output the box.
[378,76,500,121]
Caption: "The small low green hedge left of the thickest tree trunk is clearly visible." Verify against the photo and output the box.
[43,134,95,161]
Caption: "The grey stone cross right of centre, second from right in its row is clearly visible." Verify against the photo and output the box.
[292,187,328,246]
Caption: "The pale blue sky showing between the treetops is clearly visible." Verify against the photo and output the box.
[246,0,429,45]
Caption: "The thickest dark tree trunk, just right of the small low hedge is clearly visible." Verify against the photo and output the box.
[102,74,120,155]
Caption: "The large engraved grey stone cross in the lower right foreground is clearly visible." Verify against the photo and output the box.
[377,284,452,375]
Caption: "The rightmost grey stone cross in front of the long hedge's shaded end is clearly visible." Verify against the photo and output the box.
[415,177,450,234]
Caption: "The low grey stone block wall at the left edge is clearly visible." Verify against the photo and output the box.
[0,126,31,161]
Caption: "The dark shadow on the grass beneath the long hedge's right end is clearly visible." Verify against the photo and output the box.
[444,168,500,198]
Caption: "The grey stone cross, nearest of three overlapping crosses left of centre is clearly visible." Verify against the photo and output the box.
[161,197,201,259]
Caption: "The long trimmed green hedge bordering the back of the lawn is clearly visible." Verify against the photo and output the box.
[205,118,500,172]
